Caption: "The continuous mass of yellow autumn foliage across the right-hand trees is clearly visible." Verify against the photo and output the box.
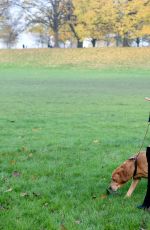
[73,0,150,38]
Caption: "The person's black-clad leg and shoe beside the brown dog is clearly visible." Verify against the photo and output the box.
[138,147,150,211]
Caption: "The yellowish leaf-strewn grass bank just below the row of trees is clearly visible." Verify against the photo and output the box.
[0,47,150,69]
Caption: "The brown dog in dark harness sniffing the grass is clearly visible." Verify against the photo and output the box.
[107,152,148,197]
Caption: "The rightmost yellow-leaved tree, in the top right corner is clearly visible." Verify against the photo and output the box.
[114,0,150,46]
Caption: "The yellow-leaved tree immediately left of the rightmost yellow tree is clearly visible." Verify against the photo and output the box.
[73,0,116,45]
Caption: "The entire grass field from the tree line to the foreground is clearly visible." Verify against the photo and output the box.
[0,49,150,230]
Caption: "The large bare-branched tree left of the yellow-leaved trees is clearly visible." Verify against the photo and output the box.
[22,0,72,47]
